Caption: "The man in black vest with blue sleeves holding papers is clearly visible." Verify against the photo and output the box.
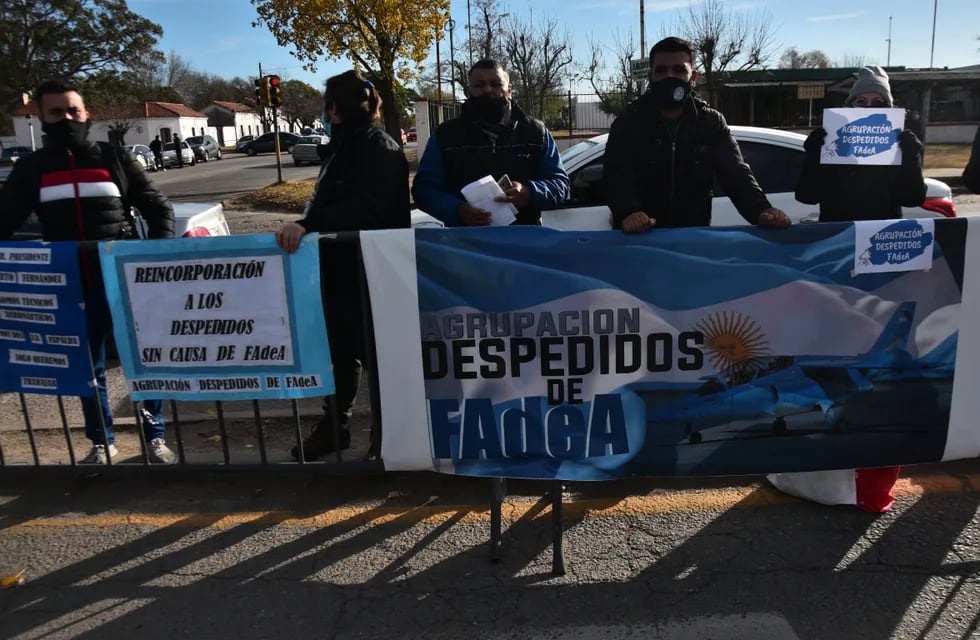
[412,60,569,227]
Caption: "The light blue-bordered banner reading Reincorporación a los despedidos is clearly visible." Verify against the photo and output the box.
[100,234,334,400]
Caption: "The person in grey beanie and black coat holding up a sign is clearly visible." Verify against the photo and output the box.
[796,65,926,222]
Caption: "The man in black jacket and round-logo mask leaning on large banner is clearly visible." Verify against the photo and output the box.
[604,37,790,233]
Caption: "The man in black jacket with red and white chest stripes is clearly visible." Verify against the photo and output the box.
[0,80,177,464]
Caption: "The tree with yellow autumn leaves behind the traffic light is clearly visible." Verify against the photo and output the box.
[252,0,449,140]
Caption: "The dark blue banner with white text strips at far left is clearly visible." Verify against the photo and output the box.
[0,241,95,396]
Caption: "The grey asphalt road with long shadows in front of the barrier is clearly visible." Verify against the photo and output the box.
[0,461,980,640]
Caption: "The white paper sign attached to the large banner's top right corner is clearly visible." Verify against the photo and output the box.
[854,218,936,273]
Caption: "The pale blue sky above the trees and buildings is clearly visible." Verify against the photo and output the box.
[129,0,980,91]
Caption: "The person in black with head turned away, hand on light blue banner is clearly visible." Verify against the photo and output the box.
[276,71,411,460]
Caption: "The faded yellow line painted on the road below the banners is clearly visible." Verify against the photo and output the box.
[0,474,980,535]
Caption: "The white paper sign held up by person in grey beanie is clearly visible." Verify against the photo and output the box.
[820,109,905,165]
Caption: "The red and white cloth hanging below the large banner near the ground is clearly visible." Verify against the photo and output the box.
[767,467,902,513]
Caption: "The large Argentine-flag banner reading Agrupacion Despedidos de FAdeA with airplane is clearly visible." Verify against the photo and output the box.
[361,220,980,479]
